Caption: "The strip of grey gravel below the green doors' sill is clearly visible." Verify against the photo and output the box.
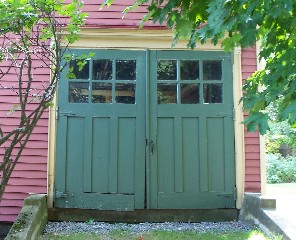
[44,221,251,234]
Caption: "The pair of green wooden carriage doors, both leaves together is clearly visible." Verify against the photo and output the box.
[55,50,235,210]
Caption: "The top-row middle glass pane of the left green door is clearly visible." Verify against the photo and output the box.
[93,60,112,80]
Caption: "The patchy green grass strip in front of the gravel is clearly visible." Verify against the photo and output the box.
[39,230,282,240]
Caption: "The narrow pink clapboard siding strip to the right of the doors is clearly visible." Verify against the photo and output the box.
[242,47,261,192]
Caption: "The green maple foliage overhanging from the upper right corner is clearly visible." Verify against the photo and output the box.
[105,0,296,134]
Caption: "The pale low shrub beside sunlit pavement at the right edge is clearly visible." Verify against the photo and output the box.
[266,154,296,183]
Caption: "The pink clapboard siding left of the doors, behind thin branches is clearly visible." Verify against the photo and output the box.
[0,54,50,222]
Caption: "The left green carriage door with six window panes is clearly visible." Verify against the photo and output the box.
[55,50,146,210]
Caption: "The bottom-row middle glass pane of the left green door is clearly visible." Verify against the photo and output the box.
[92,83,112,103]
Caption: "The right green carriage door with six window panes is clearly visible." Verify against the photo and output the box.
[148,51,235,209]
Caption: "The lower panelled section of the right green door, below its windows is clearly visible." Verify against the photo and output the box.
[157,117,235,209]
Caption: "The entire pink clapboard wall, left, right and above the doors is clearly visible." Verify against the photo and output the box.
[0,0,260,222]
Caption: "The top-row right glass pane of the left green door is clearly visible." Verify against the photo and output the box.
[116,60,136,80]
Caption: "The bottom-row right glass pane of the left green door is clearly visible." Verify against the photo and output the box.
[115,83,136,104]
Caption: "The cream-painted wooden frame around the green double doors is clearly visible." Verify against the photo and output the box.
[47,29,245,209]
